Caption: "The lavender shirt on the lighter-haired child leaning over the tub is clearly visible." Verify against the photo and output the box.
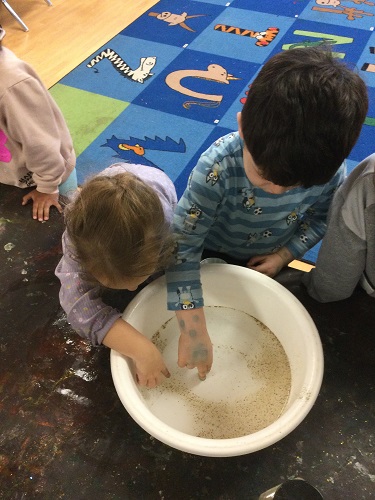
[55,163,177,345]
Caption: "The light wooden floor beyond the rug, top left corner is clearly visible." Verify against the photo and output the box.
[0,0,157,88]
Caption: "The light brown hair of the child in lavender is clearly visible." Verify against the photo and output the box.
[65,172,174,283]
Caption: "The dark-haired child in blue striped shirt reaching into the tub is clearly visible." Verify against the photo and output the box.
[167,47,368,379]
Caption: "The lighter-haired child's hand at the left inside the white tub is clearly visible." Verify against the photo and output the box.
[133,338,171,389]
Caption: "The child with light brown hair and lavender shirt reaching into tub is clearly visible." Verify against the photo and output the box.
[56,163,177,387]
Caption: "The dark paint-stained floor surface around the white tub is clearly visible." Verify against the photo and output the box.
[0,185,375,500]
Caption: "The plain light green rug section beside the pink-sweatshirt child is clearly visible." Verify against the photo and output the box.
[50,83,129,156]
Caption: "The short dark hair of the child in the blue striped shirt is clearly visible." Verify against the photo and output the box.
[242,47,368,187]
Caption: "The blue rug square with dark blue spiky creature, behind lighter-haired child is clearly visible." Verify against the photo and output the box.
[78,105,215,187]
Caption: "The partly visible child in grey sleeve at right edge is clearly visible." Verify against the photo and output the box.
[302,154,375,302]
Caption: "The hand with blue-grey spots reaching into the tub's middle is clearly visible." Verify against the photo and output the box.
[176,308,213,380]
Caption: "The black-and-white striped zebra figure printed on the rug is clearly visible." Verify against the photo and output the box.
[86,48,156,83]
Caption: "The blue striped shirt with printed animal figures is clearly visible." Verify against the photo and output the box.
[166,132,345,310]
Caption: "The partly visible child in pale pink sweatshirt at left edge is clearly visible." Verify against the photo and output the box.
[0,26,77,221]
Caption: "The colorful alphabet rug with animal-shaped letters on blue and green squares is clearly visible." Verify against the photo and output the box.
[51,0,375,261]
